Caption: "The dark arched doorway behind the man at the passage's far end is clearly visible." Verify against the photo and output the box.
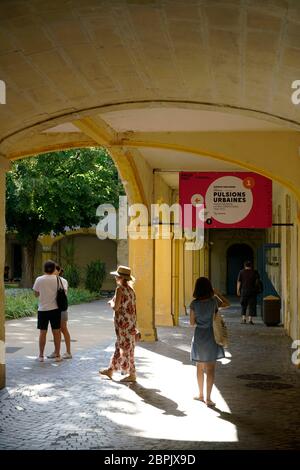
[227,243,254,295]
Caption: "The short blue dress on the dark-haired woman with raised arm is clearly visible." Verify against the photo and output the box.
[190,297,225,362]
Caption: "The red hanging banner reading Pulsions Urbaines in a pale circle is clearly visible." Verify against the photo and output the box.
[179,172,272,228]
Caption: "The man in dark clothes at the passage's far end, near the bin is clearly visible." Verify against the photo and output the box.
[237,261,259,325]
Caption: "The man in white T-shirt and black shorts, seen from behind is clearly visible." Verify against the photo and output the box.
[33,260,62,362]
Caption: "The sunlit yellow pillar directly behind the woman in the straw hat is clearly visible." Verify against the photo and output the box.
[129,237,157,341]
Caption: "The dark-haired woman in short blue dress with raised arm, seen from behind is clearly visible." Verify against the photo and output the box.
[190,277,230,406]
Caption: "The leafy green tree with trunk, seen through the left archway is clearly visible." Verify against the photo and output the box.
[6,148,124,287]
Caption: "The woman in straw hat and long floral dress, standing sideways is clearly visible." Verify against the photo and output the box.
[100,266,138,382]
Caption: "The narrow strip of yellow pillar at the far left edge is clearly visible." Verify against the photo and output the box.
[0,156,10,389]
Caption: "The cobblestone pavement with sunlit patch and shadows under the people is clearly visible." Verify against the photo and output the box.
[0,302,300,450]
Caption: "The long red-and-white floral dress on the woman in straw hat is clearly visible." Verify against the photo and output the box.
[109,285,137,374]
